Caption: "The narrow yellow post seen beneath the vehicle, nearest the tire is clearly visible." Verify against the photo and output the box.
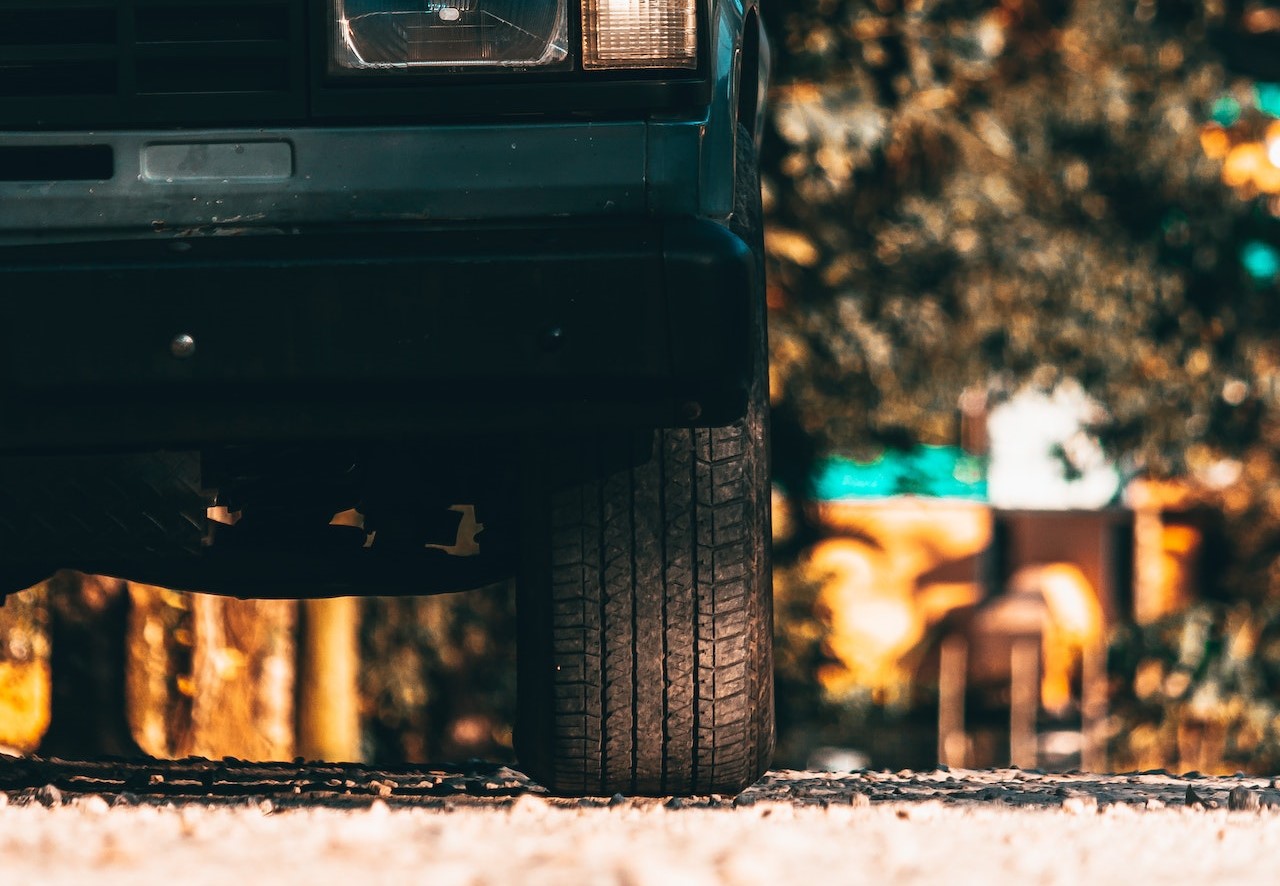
[298,597,361,762]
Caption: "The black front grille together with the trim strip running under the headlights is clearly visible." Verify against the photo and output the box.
[0,0,712,131]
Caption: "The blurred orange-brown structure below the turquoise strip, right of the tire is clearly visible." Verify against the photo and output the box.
[810,497,1134,771]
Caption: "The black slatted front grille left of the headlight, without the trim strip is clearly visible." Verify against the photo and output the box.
[0,0,307,128]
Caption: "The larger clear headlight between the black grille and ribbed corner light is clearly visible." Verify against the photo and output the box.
[334,0,568,69]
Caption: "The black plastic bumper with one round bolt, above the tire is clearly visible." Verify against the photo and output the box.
[0,220,756,451]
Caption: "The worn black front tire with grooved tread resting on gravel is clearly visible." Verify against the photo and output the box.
[517,411,773,795]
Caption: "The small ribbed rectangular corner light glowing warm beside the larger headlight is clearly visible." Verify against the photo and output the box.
[582,0,698,68]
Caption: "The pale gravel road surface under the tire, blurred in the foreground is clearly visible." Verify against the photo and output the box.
[0,757,1280,886]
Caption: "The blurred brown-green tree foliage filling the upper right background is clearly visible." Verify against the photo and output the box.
[764,0,1280,583]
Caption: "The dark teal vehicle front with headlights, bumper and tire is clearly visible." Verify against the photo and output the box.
[0,0,773,795]
